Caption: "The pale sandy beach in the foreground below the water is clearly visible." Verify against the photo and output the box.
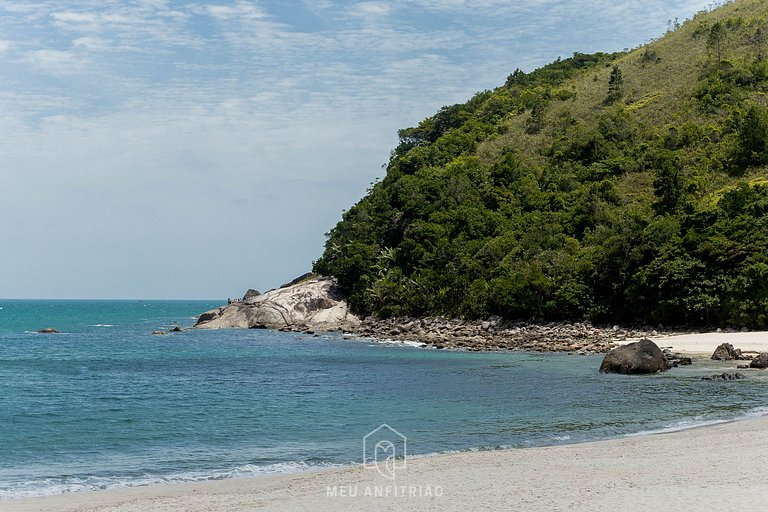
[9,416,768,512]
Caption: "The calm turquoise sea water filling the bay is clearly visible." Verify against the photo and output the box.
[0,300,768,498]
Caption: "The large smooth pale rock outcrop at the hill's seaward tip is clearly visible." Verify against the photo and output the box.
[195,277,360,331]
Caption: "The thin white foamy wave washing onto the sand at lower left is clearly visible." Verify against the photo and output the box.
[0,462,343,500]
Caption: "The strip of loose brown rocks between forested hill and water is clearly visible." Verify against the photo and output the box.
[353,317,672,354]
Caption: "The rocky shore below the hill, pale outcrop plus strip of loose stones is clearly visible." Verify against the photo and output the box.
[195,274,704,354]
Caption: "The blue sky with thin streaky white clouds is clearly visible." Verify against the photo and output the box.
[0,0,711,299]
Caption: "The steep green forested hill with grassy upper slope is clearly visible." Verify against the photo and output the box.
[315,0,768,327]
